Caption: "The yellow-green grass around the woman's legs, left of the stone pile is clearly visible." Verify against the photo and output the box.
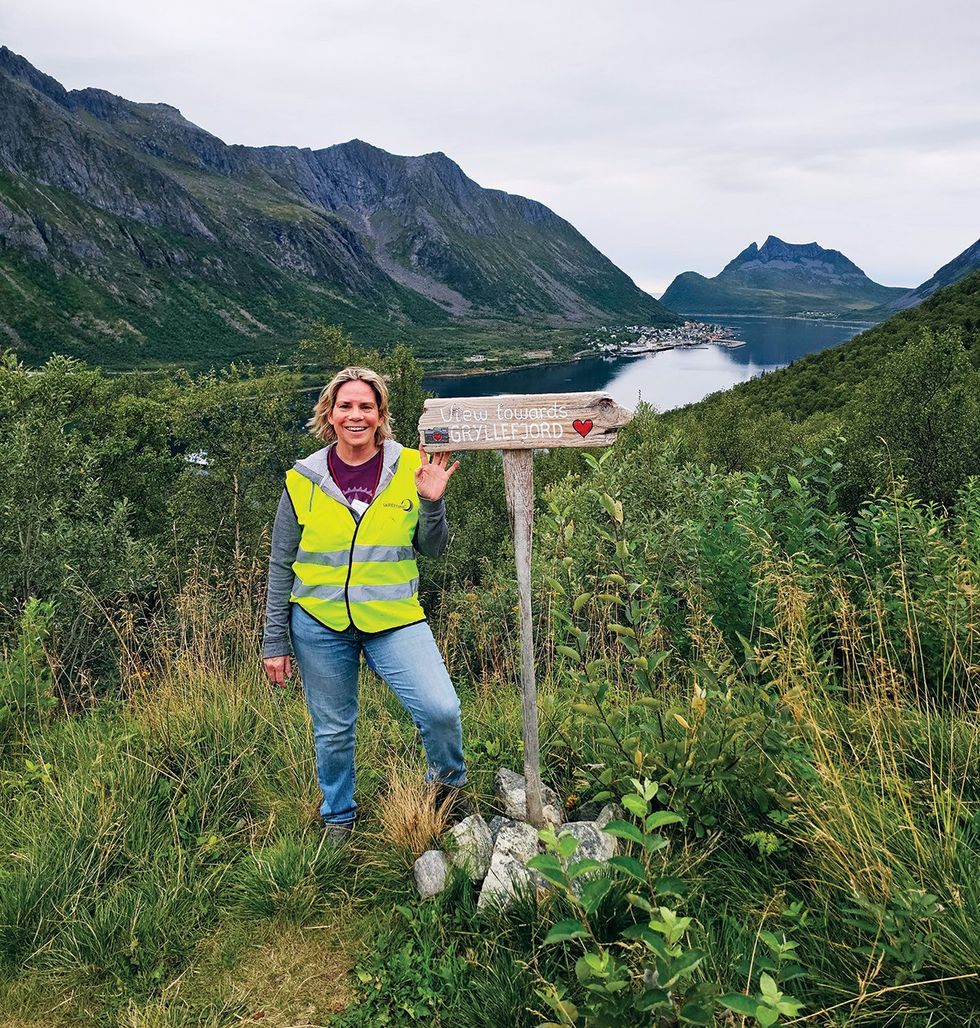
[0,567,547,1025]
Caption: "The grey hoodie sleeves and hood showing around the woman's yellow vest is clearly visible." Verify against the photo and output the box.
[262,439,449,657]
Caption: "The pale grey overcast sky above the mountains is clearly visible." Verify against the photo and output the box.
[0,0,980,294]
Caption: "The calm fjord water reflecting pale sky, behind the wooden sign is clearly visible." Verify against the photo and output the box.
[425,317,868,410]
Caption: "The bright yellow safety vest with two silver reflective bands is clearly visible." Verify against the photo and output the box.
[286,448,426,632]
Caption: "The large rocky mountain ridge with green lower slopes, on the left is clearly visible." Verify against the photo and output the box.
[0,47,674,367]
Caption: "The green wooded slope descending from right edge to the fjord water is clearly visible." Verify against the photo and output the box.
[666,272,980,506]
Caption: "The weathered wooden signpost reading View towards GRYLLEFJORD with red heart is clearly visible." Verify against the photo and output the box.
[419,393,632,829]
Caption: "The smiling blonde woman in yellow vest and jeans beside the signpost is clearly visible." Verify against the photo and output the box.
[262,368,466,841]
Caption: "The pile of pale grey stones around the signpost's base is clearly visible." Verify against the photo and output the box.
[414,768,620,908]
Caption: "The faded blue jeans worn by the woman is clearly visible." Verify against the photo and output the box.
[290,603,466,824]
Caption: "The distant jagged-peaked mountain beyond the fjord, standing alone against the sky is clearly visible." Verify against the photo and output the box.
[660,235,906,316]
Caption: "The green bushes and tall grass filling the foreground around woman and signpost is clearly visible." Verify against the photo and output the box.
[0,308,980,1028]
